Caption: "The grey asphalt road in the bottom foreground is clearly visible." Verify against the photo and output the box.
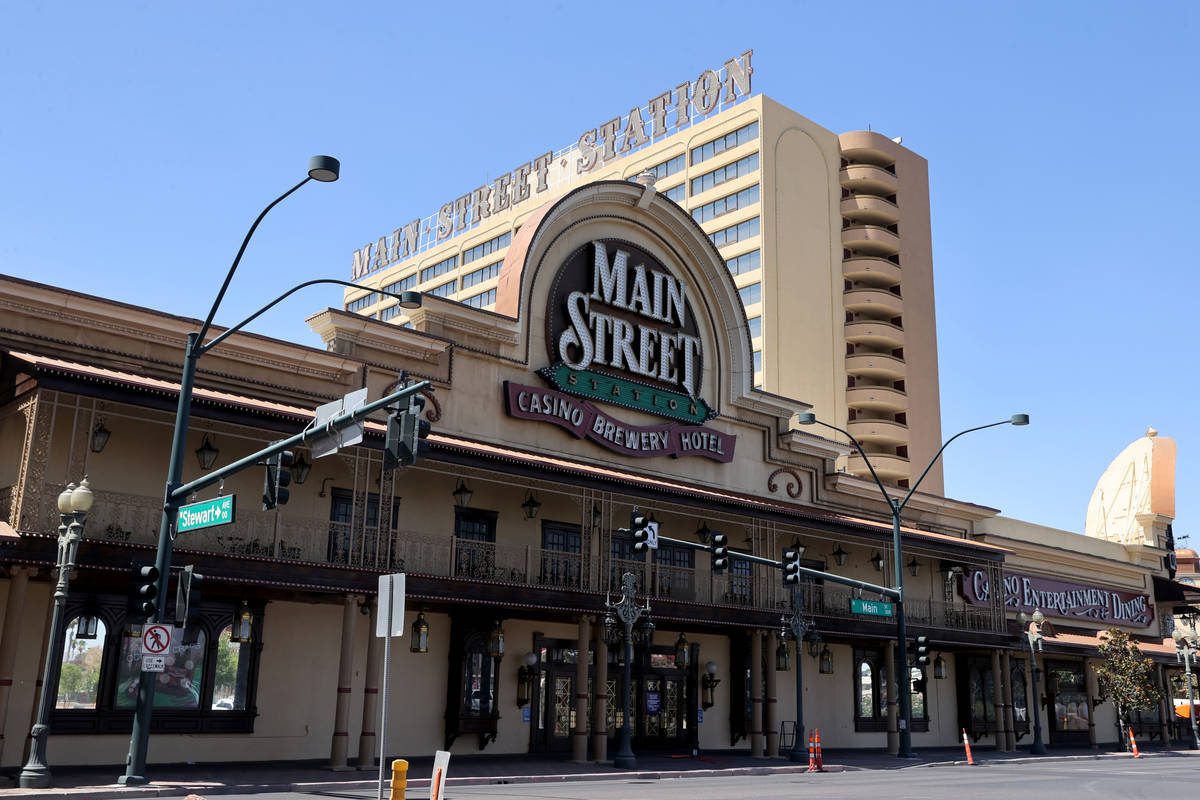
[204,758,1200,800]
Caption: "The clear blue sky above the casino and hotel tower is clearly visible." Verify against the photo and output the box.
[0,0,1200,537]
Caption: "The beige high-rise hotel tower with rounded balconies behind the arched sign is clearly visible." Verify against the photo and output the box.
[346,86,943,493]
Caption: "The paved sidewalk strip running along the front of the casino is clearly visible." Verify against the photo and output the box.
[0,747,1200,800]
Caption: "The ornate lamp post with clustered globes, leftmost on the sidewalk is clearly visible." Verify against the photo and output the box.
[19,476,94,789]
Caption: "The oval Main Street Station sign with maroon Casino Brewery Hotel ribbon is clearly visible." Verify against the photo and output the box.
[504,239,737,463]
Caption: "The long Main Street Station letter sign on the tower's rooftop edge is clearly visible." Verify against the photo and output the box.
[350,50,754,281]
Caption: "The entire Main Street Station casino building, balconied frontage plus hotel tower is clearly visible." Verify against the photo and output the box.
[0,53,1196,768]
